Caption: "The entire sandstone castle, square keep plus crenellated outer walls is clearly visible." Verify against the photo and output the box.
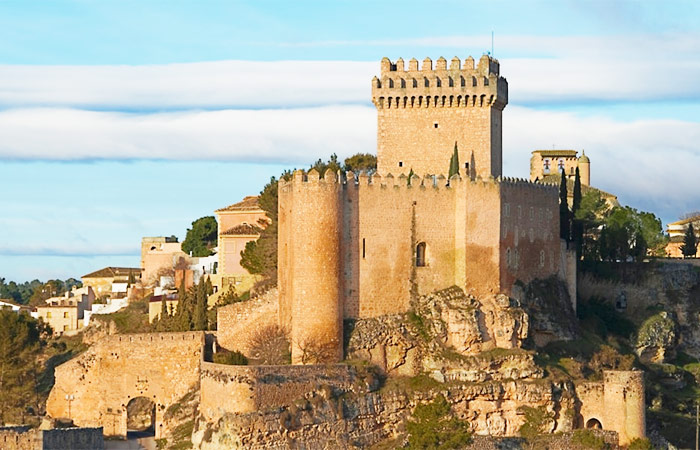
[278,55,575,363]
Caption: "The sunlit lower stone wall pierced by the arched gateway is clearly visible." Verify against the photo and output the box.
[46,332,204,438]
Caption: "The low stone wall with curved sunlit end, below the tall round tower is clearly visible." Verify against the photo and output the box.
[199,362,354,422]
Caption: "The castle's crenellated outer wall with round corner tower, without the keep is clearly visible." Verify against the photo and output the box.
[278,171,560,362]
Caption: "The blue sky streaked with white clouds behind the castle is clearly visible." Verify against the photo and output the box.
[0,0,700,281]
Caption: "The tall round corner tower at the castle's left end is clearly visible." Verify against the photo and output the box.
[278,170,343,364]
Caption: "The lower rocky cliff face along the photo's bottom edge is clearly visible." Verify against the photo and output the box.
[195,381,575,450]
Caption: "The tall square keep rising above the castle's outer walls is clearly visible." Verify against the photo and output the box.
[372,55,508,178]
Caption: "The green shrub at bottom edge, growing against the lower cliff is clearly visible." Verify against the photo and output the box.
[406,394,472,450]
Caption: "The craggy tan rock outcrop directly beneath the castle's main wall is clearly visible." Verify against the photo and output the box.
[346,287,543,382]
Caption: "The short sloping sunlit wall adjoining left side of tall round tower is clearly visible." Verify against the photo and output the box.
[216,289,279,356]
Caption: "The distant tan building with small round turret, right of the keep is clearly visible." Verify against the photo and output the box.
[530,150,591,186]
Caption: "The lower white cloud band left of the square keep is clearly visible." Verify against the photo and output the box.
[0,106,376,165]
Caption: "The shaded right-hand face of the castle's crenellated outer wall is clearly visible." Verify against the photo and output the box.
[500,179,562,290]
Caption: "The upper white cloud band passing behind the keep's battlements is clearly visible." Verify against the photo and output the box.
[0,33,700,111]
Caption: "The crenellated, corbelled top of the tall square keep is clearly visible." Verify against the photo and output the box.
[372,55,508,110]
